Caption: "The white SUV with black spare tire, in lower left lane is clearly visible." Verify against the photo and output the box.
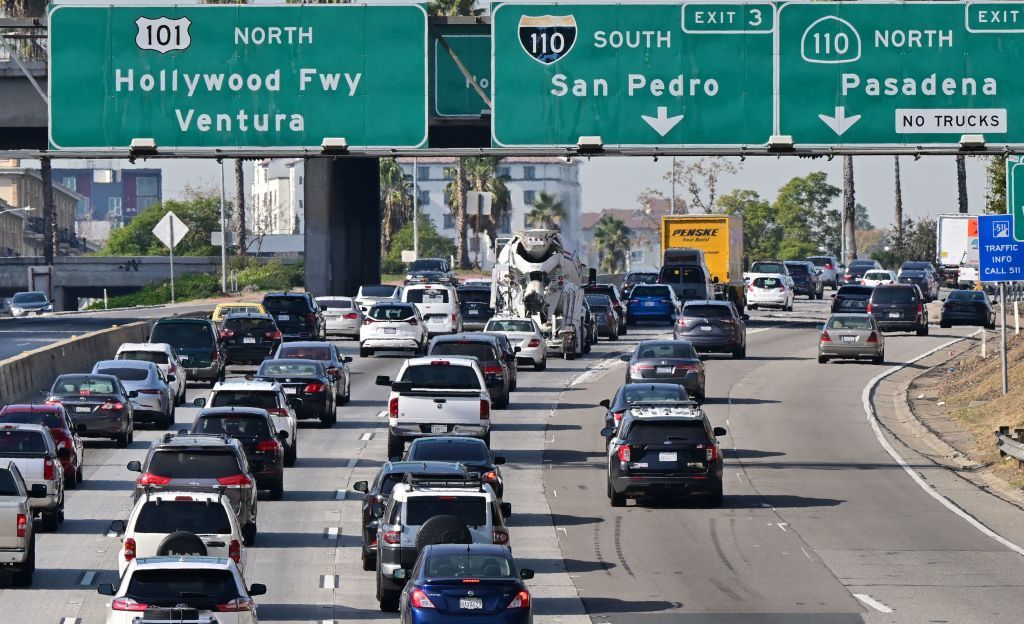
[111,491,245,575]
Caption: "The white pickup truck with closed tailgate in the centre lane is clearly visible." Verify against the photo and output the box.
[377,357,490,459]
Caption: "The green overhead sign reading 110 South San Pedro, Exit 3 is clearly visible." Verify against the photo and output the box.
[492,2,775,147]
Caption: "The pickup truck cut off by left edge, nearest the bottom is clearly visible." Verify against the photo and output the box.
[0,461,46,587]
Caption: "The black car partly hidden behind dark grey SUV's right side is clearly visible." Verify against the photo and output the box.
[190,408,288,500]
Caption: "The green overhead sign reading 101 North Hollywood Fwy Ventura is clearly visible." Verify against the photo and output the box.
[49,4,427,150]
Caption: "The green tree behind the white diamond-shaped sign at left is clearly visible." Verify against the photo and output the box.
[100,192,226,256]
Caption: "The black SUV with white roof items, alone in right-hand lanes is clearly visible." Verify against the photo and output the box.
[601,402,726,507]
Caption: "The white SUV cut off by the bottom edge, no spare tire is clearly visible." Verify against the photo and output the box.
[96,556,266,624]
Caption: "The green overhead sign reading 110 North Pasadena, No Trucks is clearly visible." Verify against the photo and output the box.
[776,2,1024,145]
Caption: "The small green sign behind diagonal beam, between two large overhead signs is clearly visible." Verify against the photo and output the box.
[433,35,490,117]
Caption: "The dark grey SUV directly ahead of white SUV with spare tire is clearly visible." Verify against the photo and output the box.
[128,433,256,546]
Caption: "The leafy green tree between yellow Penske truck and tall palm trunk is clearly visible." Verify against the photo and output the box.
[773,171,842,259]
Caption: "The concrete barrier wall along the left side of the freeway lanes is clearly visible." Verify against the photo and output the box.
[0,321,151,405]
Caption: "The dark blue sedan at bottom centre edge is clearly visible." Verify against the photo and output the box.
[400,544,534,624]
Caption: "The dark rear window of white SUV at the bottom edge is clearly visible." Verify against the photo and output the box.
[125,568,239,608]
